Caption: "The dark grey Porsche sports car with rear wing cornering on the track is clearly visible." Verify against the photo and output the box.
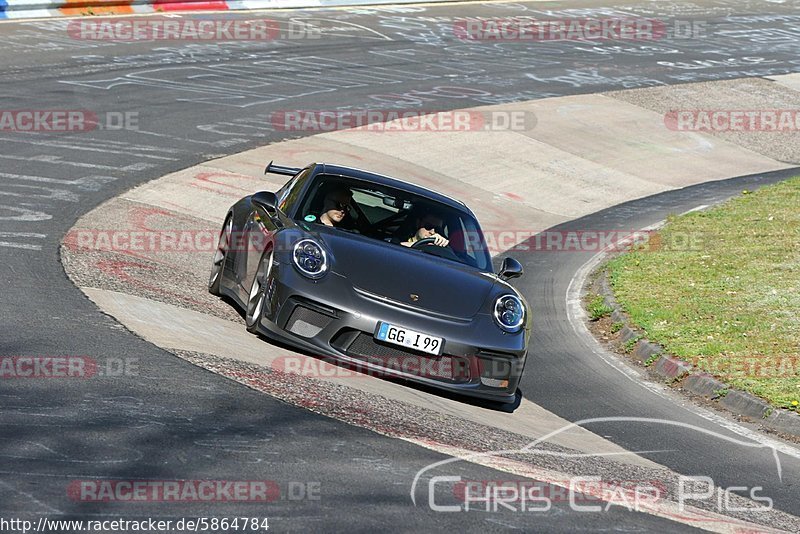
[208,163,531,402]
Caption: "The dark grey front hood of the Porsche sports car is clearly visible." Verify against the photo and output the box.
[318,230,496,318]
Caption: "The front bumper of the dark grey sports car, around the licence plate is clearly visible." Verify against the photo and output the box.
[260,262,529,402]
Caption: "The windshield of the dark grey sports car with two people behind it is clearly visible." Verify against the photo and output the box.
[295,175,491,271]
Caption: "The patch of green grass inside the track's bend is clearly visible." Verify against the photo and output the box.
[608,177,800,410]
